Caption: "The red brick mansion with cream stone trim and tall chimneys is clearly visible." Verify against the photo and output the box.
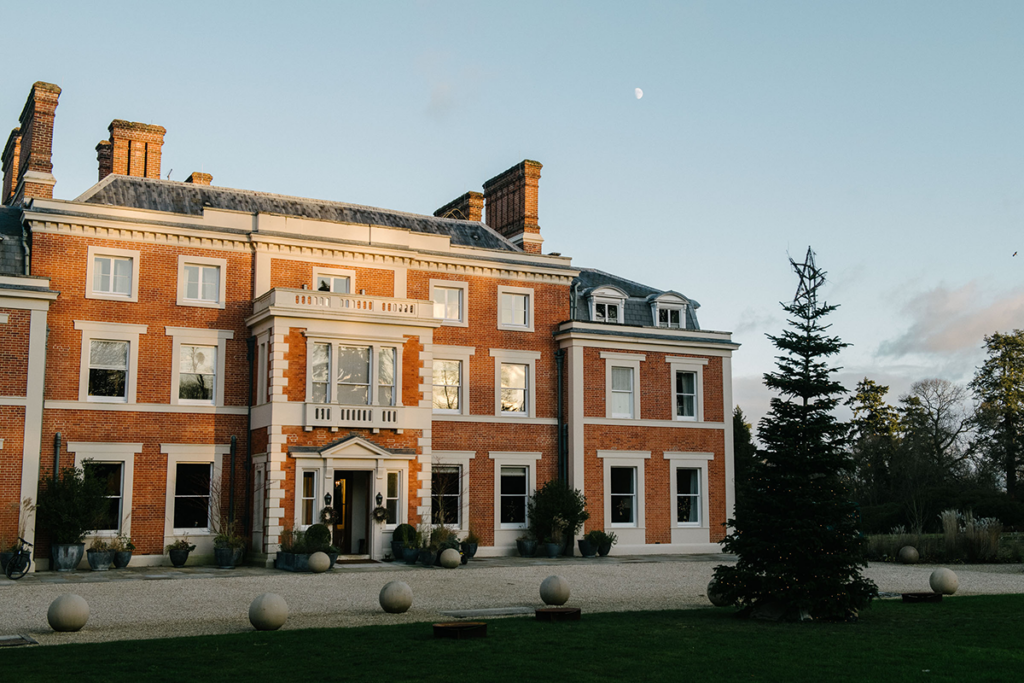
[0,83,737,569]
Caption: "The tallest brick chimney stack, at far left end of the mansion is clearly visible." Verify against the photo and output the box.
[2,81,60,204]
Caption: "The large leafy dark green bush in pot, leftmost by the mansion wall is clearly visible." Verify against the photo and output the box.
[37,467,110,571]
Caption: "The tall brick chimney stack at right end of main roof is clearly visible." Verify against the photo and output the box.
[483,159,544,254]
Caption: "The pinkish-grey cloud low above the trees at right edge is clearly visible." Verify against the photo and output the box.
[878,282,1024,357]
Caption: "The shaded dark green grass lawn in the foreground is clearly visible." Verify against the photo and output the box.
[0,595,1024,683]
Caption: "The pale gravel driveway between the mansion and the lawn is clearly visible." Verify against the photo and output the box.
[0,555,1024,644]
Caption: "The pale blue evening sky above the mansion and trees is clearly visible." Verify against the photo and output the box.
[8,0,1024,432]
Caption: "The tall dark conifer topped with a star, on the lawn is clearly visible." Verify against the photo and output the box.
[715,248,878,620]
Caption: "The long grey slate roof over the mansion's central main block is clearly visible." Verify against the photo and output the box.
[77,174,522,253]
